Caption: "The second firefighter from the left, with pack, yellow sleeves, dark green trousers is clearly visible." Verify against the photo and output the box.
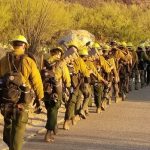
[41,47,71,142]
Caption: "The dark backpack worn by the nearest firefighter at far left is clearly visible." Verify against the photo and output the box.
[0,53,23,104]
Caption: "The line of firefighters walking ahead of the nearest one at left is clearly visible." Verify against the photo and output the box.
[41,41,150,142]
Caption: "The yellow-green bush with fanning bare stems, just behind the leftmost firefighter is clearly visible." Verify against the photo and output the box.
[11,0,72,52]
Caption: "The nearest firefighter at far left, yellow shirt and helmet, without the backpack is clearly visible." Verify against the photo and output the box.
[0,35,44,150]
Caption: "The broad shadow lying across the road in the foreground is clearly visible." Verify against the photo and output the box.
[24,131,150,150]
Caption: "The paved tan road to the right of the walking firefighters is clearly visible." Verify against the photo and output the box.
[23,87,150,150]
